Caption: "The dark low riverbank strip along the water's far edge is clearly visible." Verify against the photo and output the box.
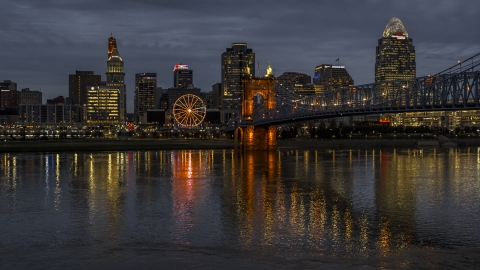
[0,139,480,153]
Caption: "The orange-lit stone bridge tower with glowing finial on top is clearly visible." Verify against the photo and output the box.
[234,64,277,150]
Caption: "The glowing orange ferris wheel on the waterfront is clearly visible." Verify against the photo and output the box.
[173,94,206,127]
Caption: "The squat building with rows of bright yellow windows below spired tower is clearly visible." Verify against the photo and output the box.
[85,86,121,125]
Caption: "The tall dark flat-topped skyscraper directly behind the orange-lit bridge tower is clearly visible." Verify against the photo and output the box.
[221,43,255,122]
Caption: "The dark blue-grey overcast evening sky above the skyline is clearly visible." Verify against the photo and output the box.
[0,0,480,112]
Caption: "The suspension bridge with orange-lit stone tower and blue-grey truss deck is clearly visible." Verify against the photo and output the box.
[226,53,480,149]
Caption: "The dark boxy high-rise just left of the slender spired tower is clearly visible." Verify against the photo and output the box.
[68,70,102,106]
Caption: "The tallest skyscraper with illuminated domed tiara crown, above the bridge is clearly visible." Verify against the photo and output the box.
[375,17,416,82]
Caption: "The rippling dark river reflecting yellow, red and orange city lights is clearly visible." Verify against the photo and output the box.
[0,148,480,269]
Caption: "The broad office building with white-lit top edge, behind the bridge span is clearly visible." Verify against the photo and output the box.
[313,64,354,94]
